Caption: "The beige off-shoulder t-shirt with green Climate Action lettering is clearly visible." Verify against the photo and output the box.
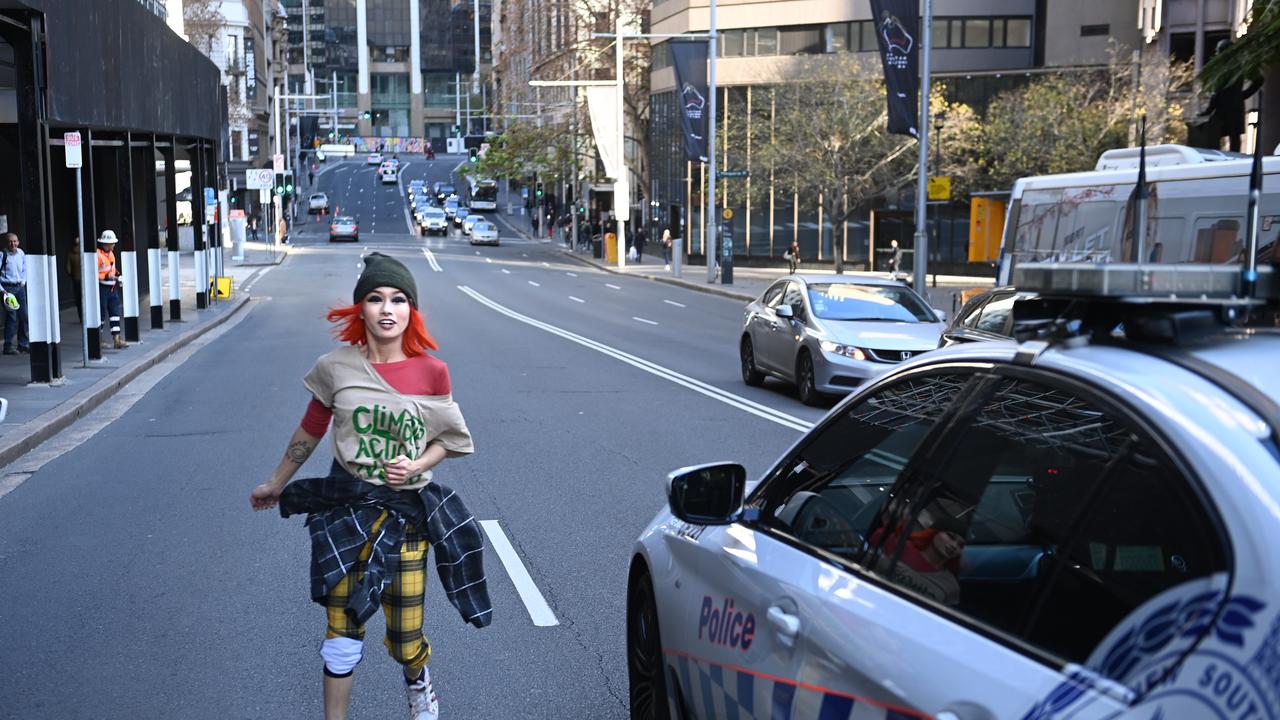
[302,345,475,489]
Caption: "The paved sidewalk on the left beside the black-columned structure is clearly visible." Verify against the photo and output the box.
[0,242,288,466]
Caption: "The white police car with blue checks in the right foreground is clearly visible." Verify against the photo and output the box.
[627,260,1280,720]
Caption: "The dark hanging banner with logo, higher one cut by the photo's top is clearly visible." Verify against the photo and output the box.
[870,0,920,137]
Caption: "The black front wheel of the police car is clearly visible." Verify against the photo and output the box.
[627,569,671,720]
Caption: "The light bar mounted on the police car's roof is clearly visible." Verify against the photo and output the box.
[1014,263,1280,305]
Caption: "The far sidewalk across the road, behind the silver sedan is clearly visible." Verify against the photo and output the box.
[483,184,995,311]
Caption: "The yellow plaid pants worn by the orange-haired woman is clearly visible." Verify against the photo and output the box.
[325,511,431,670]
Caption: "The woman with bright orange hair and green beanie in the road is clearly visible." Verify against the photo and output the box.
[250,252,493,720]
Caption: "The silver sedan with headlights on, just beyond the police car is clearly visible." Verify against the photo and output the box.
[739,274,946,405]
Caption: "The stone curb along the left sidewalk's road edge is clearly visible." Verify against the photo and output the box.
[0,296,250,468]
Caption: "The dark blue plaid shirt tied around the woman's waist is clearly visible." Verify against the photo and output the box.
[280,462,493,628]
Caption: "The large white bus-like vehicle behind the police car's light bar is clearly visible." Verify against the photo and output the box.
[996,145,1280,284]
